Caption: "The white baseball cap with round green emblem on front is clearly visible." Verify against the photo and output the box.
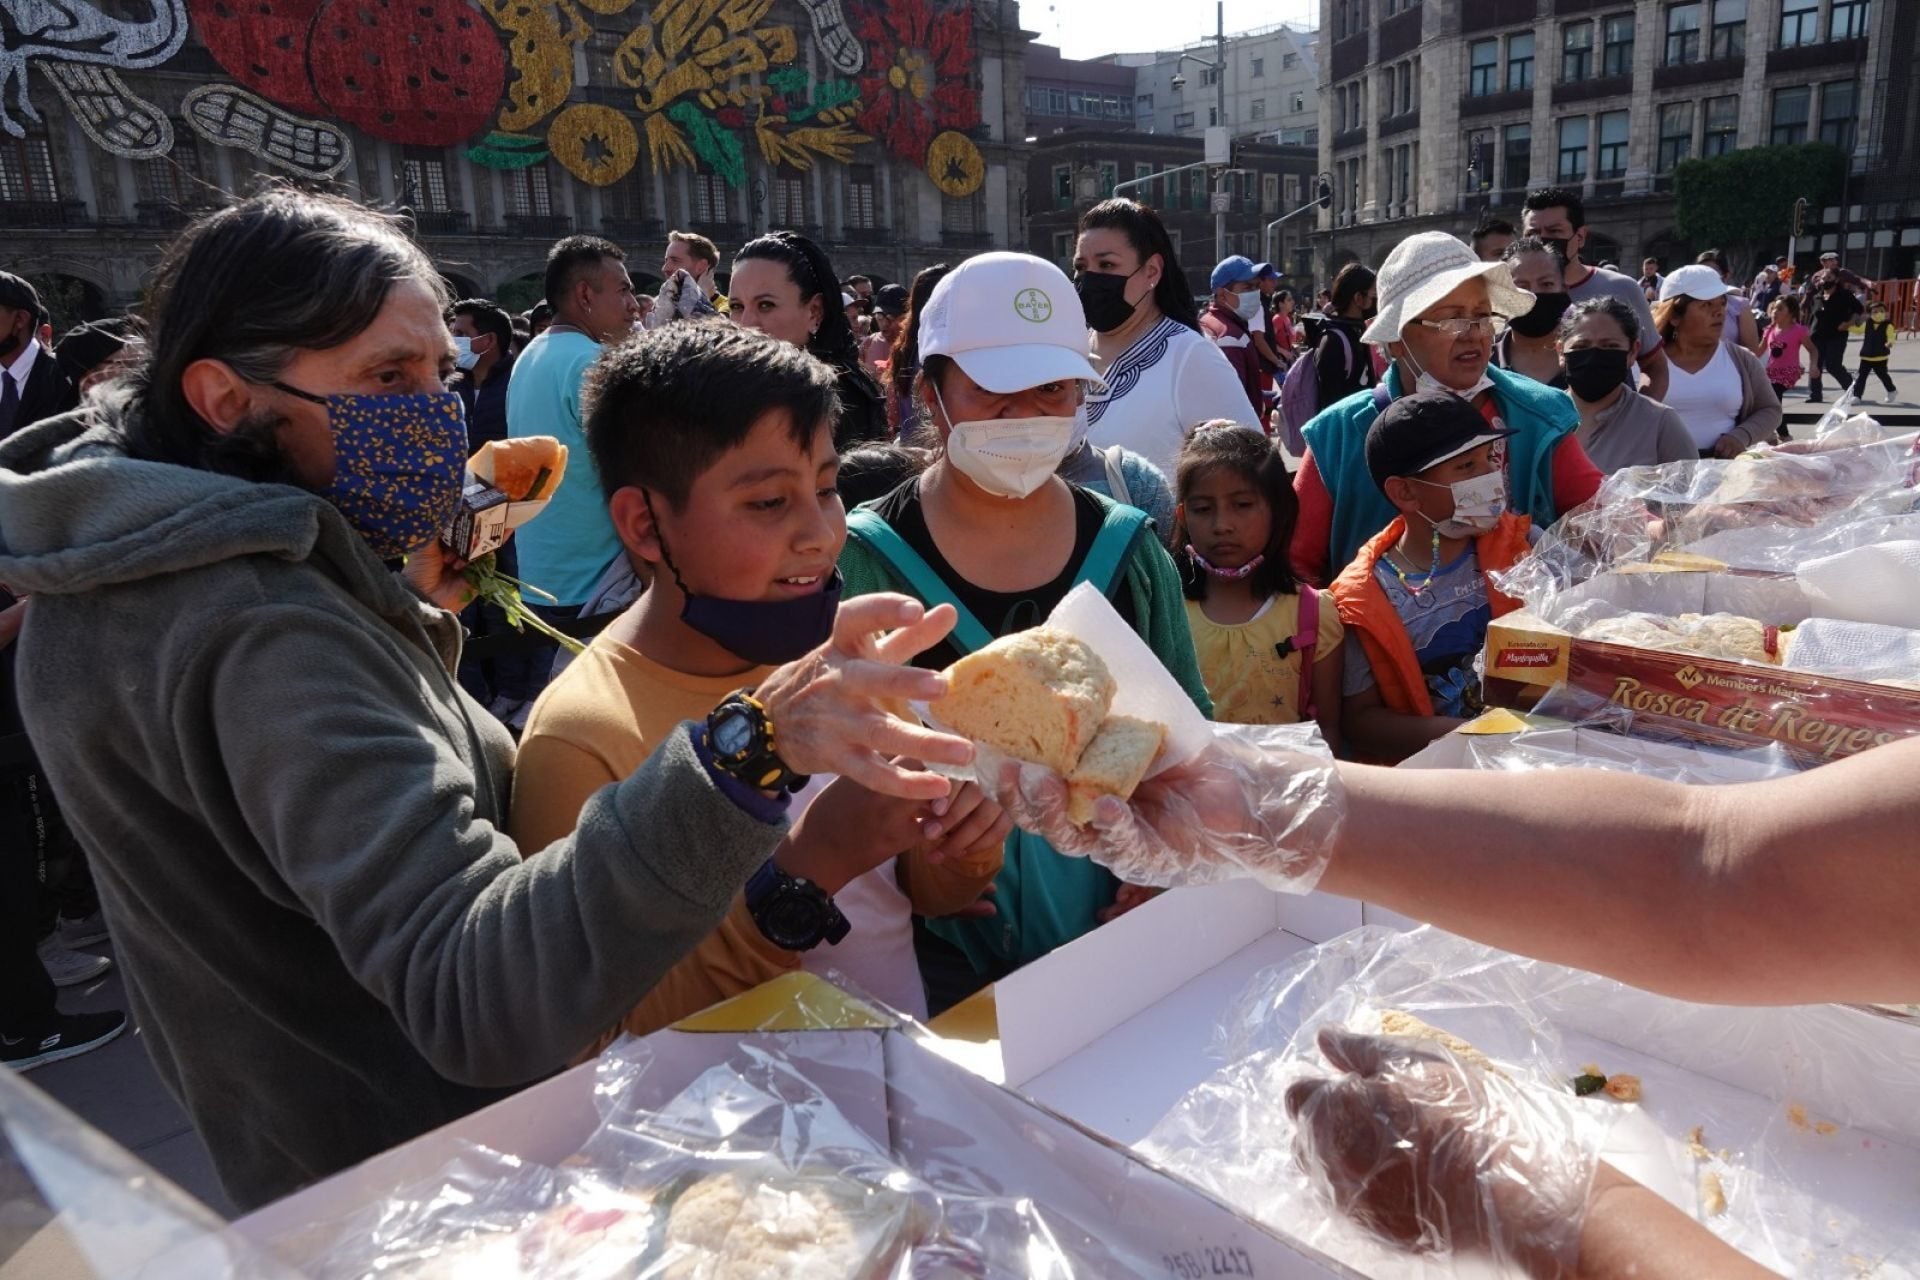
[920,253,1104,395]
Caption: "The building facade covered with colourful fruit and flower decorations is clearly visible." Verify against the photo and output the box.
[0,0,1036,315]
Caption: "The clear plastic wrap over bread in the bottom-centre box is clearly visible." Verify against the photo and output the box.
[309,1032,1152,1280]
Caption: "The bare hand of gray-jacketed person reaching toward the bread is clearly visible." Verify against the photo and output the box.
[755,595,973,802]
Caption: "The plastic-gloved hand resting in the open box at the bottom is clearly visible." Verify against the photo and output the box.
[1286,1027,1599,1276]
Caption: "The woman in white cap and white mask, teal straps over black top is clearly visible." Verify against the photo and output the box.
[839,253,1205,1011]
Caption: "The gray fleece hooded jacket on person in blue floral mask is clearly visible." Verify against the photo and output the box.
[0,403,781,1207]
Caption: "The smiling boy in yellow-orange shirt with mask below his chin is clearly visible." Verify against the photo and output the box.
[511,324,1010,1048]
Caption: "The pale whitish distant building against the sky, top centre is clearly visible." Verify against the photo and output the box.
[1119,22,1321,146]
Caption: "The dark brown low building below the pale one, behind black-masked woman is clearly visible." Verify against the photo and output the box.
[1027,130,1317,296]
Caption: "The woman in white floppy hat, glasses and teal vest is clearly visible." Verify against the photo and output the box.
[1294,230,1601,581]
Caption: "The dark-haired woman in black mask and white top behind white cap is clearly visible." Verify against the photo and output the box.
[1054,198,1258,476]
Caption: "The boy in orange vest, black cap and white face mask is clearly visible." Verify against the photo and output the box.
[1332,391,1532,764]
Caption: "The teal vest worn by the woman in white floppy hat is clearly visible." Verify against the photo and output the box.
[1302,365,1580,578]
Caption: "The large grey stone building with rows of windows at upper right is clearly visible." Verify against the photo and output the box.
[1315,0,1920,276]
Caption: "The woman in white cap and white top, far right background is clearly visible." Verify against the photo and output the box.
[1653,263,1782,459]
